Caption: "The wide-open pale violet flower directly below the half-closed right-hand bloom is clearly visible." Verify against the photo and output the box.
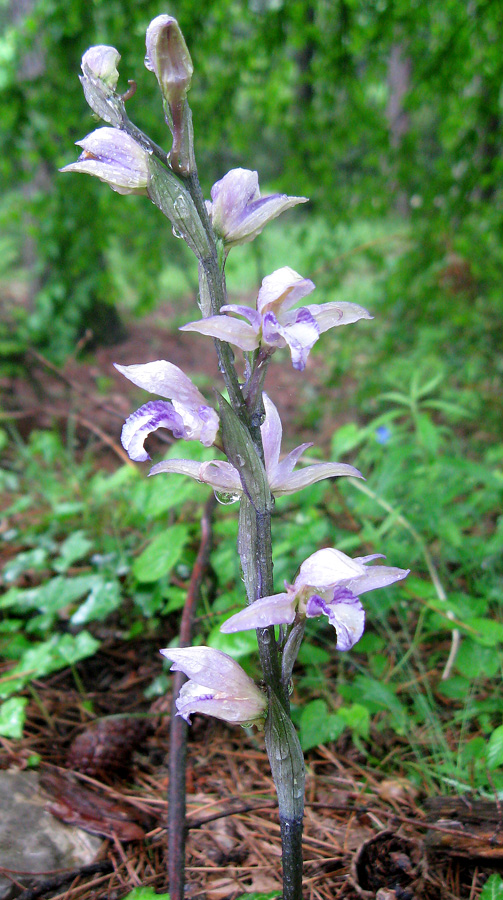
[180,266,372,371]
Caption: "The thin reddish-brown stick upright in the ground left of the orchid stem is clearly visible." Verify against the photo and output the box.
[168,494,216,900]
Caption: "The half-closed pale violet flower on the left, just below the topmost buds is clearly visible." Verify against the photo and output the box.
[59,128,149,194]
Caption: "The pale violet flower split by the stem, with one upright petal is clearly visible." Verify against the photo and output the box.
[149,394,363,497]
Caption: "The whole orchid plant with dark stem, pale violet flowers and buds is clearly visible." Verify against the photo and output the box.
[61,15,408,900]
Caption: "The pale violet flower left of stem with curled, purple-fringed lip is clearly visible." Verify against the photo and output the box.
[115,359,219,460]
